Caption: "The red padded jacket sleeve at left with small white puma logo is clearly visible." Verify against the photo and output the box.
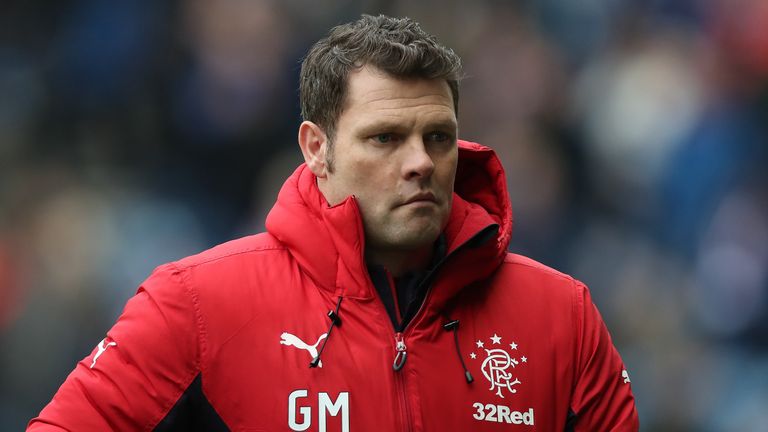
[27,265,202,431]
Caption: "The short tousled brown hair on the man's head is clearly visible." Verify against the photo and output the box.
[299,15,461,141]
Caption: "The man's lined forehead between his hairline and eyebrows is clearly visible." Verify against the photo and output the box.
[340,66,456,123]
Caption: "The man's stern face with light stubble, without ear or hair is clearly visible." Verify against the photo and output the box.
[320,67,458,251]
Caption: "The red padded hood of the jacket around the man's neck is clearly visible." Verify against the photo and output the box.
[266,140,512,302]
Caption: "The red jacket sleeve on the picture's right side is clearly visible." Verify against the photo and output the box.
[566,282,640,432]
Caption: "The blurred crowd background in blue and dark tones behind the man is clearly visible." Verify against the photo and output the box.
[0,0,768,432]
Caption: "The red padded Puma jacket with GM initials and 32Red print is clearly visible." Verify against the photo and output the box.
[28,142,638,432]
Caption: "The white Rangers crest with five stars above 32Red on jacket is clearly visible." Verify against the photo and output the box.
[469,333,528,398]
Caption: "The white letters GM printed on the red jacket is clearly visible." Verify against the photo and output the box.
[288,389,349,432]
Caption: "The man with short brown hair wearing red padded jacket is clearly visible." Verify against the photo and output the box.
[29,16,638,431]
